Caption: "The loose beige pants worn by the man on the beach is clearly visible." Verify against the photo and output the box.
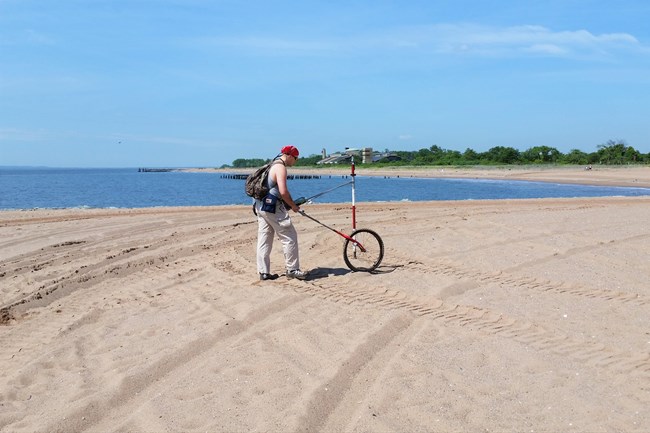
[255,200,300,274]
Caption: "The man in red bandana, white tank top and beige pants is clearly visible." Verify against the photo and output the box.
[255,146,307,280]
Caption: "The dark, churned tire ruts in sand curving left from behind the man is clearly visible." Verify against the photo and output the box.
[0,218,256,325]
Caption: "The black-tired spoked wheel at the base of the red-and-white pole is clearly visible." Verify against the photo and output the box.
[343,229,384,272]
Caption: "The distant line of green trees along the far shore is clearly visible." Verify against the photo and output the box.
[225,140,650,168]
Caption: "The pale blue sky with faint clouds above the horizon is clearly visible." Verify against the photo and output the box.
[0,0,650,167]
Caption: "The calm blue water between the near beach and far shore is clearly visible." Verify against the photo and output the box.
[0,168,650,209]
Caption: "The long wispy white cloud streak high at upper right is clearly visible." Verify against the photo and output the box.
[191,23,647,57]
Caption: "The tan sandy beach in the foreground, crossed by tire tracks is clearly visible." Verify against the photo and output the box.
[0,168,650,432]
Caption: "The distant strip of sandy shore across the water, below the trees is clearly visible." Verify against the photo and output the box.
[185,165,650,188]
